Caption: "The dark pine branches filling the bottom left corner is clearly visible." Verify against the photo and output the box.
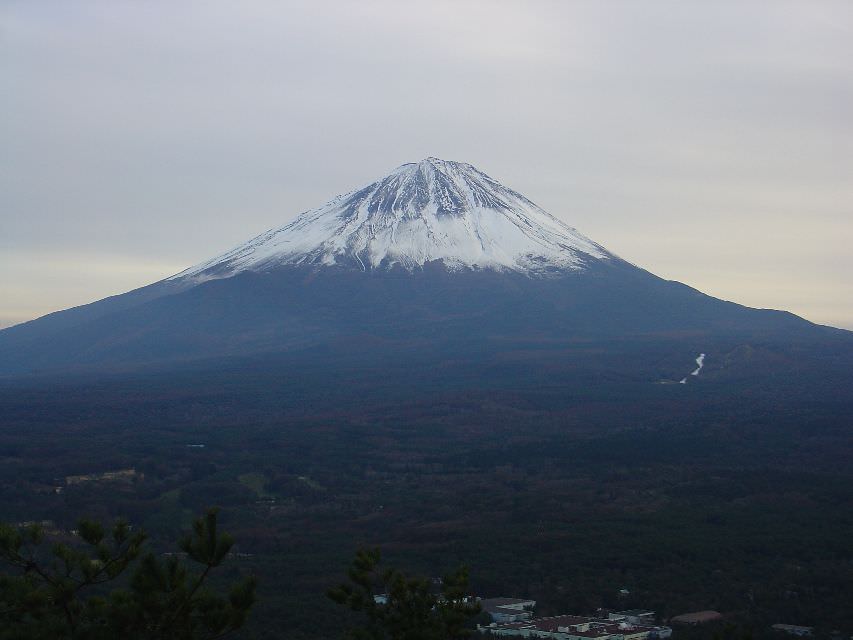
[0,509,255,640]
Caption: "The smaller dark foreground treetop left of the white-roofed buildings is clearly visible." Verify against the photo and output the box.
[328,549,480,640]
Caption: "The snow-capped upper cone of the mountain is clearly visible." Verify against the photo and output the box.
[172,158,614,281]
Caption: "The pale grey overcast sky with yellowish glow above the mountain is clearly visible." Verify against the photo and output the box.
[0,0,853,328]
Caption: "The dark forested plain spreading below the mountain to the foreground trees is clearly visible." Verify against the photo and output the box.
[0,342,853,640]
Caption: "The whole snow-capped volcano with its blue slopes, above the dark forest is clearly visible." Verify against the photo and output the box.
[0,158,849,380]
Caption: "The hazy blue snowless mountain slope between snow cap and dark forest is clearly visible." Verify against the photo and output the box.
[0,263,850,374]
